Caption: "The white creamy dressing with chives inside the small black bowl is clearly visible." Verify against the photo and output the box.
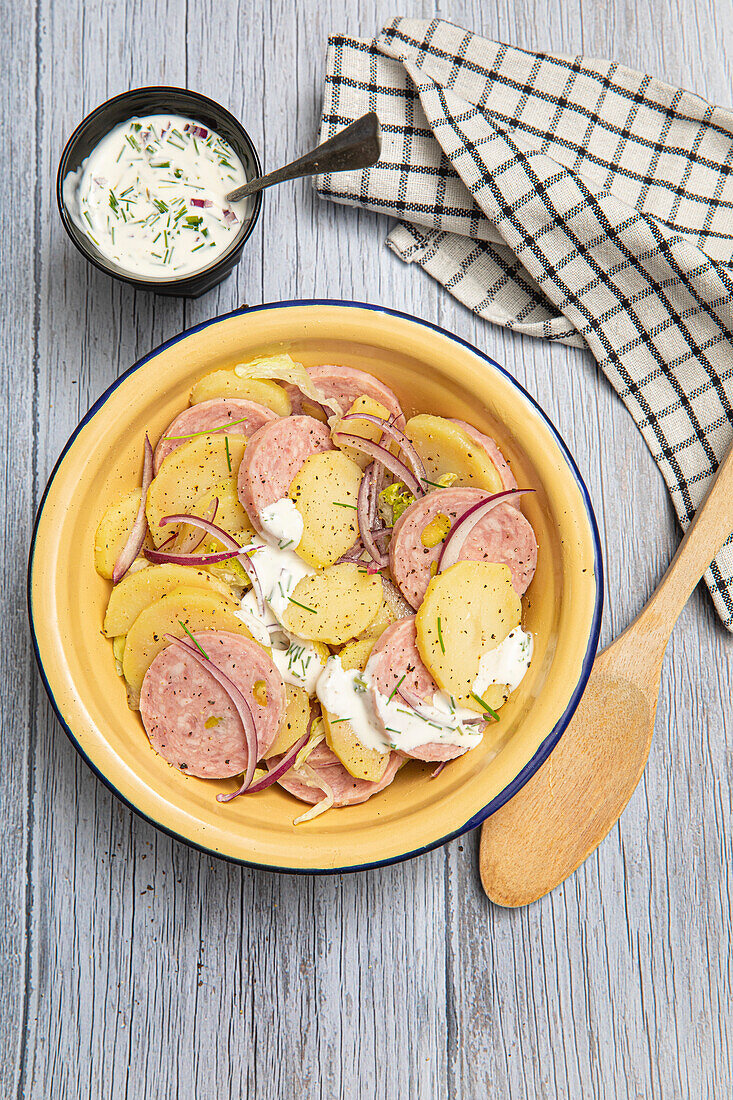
[63,114,252,278]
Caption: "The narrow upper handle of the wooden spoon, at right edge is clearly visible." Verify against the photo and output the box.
[635,447,733,652]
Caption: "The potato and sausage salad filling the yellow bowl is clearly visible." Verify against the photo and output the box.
[95,354,537,824]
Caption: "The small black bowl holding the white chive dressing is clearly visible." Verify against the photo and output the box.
[56,87,262,298]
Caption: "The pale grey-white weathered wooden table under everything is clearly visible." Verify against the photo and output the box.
[7,0,733,1100]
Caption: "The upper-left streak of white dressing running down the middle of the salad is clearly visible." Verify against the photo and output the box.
[238,497,324,695]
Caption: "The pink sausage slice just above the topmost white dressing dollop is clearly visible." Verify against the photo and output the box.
[238,416,333,531]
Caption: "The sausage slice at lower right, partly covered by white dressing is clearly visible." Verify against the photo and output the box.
[367,615,467,761]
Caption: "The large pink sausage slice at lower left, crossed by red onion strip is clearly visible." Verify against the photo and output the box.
[140,630,286,779]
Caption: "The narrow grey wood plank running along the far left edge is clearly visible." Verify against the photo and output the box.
[0,2,40,1096]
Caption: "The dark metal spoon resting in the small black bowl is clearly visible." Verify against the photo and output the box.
[227,111,382,202]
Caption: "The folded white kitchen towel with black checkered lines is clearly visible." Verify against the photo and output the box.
[316,19,733,630]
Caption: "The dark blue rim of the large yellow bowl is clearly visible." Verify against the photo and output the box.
[28,298,603,875]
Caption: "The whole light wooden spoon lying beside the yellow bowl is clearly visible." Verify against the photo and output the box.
[480,449,733,906]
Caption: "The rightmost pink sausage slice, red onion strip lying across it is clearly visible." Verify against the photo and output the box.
[390,488,537,608]
